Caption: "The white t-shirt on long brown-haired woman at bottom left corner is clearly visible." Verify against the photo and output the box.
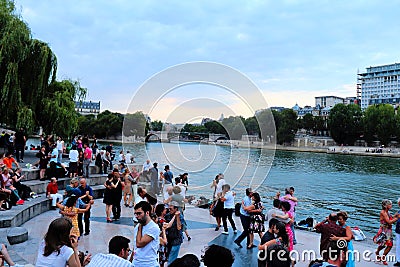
[35,240,74,267]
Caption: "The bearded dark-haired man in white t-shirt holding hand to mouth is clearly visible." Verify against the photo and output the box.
[133,201,160,267]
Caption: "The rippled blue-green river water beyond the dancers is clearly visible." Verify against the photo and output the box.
[105,143,400,236]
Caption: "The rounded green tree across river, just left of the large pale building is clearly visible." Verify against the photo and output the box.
[328,104,362,145]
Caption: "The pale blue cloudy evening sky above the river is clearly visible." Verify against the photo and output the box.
[15,0,400,123]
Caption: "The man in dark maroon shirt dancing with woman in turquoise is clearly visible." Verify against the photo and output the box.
[315,213,346,261]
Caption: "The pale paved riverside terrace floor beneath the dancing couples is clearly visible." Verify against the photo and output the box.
[0,202,394,267]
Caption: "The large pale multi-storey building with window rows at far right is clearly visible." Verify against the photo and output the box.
[358,63,400,109]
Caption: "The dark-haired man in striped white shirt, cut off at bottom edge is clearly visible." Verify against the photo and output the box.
[87,235,132,267]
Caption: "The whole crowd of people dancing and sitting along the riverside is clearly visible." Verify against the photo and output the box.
[0,134,400,267]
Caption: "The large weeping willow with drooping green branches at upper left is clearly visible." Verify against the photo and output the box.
[0,0,86,137]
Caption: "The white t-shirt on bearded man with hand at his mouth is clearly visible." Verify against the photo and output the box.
[133,220,160,267]
